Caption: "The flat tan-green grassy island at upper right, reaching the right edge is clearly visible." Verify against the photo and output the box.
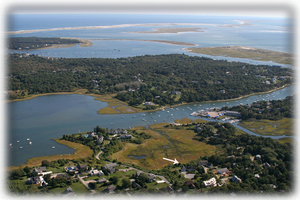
[185,46,294,65]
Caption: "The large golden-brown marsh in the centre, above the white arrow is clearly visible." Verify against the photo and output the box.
[111,123,217,169]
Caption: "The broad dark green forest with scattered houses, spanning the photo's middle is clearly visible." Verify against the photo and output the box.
[6,54,293,106]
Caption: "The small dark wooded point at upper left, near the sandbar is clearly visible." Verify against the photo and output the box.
[7,37,80,50]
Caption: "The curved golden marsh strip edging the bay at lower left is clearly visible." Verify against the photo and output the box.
[8,139,93,170]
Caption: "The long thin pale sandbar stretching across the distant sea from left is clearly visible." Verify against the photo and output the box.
[6,23,204,35]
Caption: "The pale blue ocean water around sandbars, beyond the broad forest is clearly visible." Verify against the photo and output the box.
[7,14,293,58]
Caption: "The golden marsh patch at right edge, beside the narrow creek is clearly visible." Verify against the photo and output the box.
[239,118,294,135]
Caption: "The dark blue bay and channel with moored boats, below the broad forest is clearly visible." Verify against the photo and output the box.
[6,85,295,166]
